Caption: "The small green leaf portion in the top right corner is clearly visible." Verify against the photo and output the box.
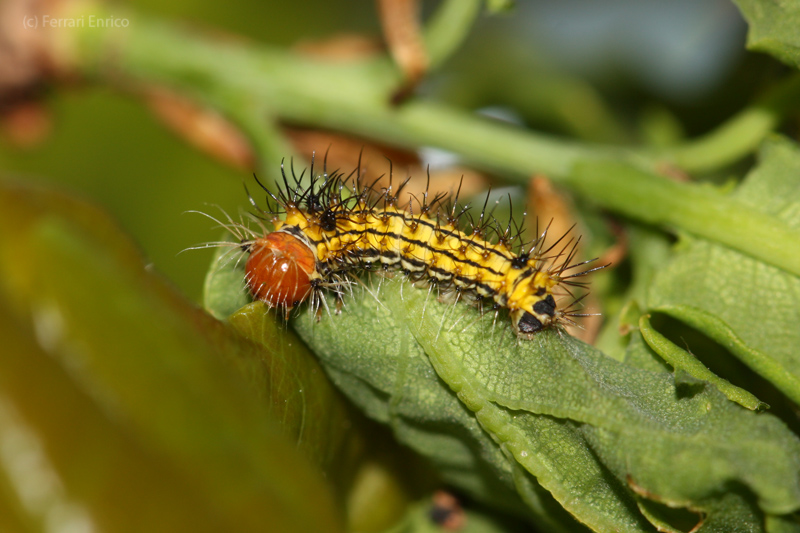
[734,0,800,68]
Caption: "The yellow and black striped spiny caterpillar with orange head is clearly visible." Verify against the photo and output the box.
[223,158,607,338]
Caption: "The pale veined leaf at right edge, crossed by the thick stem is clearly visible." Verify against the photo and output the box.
[648,138,800,403]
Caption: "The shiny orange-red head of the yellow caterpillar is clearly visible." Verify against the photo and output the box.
[245,231,318,313]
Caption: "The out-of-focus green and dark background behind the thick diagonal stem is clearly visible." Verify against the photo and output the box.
[0,0,764,300]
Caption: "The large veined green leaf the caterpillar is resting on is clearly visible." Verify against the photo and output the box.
[290,272,800,531]
